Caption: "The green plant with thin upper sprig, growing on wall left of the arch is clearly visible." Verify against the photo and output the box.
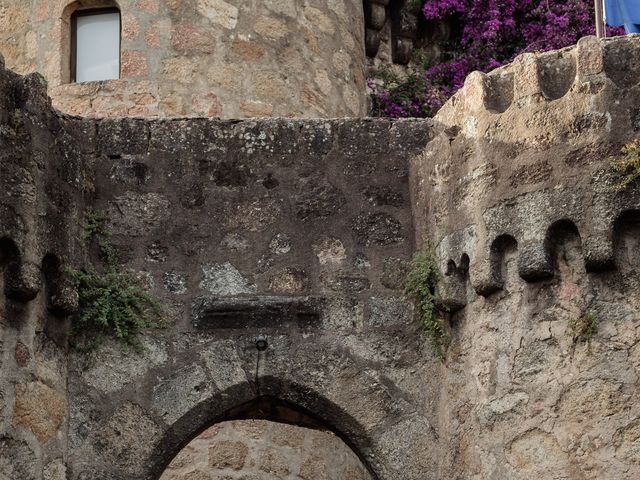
[69,210,164,351]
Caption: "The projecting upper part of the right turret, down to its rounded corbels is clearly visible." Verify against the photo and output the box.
[414,36,640,309]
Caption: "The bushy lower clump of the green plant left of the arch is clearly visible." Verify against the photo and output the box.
[69,269,164,351]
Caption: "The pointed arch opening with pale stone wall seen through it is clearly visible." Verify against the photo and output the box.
[160,397,373,480]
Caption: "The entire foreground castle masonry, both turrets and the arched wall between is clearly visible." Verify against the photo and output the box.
[0,36,640,480]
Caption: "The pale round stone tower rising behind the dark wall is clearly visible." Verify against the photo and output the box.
[0,0,367,118]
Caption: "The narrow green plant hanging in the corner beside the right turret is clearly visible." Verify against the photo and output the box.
[404,245,450,358]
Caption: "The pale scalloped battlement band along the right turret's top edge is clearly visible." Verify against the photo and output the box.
[436,35,640,130]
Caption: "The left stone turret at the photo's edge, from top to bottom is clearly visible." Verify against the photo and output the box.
[0,69,79,480]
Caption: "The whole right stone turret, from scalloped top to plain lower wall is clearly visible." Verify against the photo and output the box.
[413,37,640,479]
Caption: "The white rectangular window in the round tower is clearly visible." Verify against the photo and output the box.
[71,8,120,82]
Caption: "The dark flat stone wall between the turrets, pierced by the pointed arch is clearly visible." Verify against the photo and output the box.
[60,119,437,480]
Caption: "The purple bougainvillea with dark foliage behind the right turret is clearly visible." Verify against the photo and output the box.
[368,0,623,118]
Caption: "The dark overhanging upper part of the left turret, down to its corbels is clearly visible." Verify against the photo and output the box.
[0,53,81,314]
